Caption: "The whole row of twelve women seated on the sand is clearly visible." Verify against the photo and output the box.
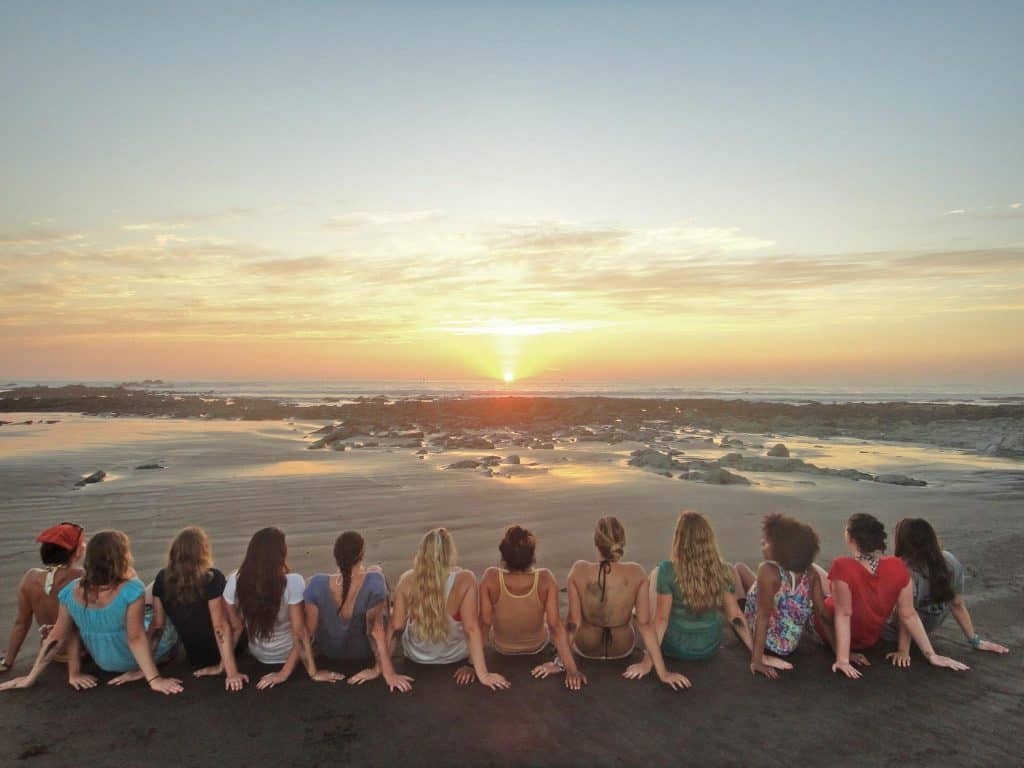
[0,512,1007,693]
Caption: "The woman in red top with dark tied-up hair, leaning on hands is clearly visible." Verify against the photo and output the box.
[814,512,969,678]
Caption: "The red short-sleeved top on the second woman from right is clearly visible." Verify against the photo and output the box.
[825,557,910,650]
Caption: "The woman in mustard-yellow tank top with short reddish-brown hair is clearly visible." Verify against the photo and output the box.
[480,525,587,690]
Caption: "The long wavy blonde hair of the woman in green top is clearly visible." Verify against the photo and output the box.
[672,510,728,613]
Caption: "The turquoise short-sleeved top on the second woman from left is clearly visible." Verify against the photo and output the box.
[57,579,177,672]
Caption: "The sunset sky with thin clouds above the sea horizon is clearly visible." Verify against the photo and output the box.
[0,0,1024,391]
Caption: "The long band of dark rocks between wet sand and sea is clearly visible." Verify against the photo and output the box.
[0,385,1024,458]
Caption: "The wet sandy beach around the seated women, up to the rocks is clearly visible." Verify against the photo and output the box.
[0,403,1024,766]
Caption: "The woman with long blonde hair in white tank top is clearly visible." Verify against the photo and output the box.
[375,528,510,690]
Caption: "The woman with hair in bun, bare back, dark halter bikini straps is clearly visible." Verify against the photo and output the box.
[566,516,647,671]
